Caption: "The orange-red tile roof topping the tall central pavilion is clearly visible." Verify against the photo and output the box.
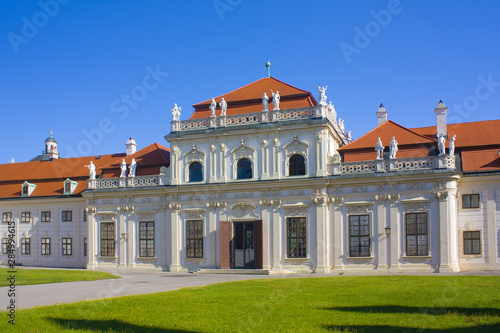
[189,77,318,119]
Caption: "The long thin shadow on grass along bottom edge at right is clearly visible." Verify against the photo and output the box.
[323,324,500,333]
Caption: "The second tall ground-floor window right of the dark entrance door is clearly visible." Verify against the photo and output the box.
[349,214,371,257]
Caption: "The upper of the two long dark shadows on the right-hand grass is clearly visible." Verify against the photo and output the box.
[323,305,500,316]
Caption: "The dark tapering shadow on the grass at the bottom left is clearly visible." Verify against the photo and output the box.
[47,318,193,333]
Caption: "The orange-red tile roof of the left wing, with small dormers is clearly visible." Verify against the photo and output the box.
[0,143,170,198]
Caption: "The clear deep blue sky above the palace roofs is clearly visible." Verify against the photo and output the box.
[0,0,500,163]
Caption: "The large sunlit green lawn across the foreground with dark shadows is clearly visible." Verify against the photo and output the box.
[0,276,500,332]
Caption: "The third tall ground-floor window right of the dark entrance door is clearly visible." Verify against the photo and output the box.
[406,213,429,256]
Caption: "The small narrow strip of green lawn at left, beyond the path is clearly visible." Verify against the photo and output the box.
[0,267,119,286]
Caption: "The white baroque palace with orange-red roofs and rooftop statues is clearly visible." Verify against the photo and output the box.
[0,77,500,273]
